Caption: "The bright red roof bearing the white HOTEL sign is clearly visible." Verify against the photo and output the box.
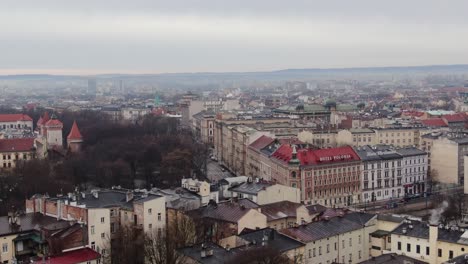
[272,144,360,166]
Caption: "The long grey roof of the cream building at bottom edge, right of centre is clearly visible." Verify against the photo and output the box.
[281,212,375,242]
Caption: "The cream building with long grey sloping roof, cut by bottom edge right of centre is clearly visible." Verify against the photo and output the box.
[281,212,377,264]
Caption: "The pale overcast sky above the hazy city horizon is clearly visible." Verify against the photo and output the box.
[0,0,468,74]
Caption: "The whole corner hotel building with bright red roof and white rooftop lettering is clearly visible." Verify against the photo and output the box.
[271,144,361,206]
